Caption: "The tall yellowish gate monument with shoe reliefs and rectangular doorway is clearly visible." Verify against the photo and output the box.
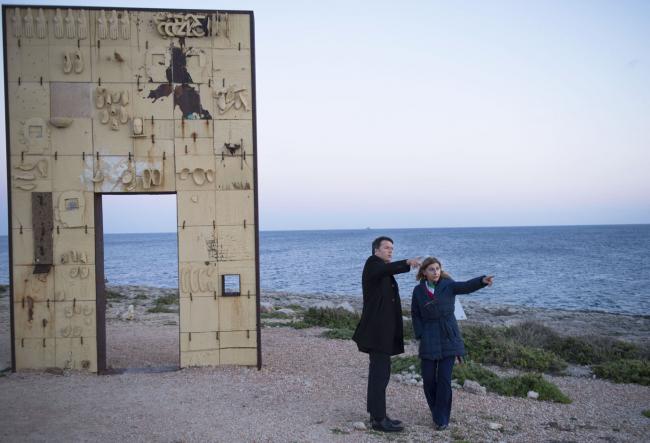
[3,6,261,372]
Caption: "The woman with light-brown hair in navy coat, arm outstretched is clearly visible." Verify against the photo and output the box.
[411,257,494,430]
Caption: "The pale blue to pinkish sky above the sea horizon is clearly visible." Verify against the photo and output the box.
[0,0,650,234]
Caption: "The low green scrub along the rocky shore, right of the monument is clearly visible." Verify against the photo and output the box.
[274,308,650,386]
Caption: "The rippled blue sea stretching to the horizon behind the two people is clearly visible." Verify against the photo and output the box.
[0,225,650,315]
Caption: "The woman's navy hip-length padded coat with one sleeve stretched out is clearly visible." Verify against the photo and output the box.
[411,276,487,360]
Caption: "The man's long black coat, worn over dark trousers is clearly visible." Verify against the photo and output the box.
[352,255,410,355]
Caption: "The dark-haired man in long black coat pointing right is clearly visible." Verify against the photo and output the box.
[352,237,420,432]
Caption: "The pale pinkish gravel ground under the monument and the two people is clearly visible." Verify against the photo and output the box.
[0,290,650,442]
